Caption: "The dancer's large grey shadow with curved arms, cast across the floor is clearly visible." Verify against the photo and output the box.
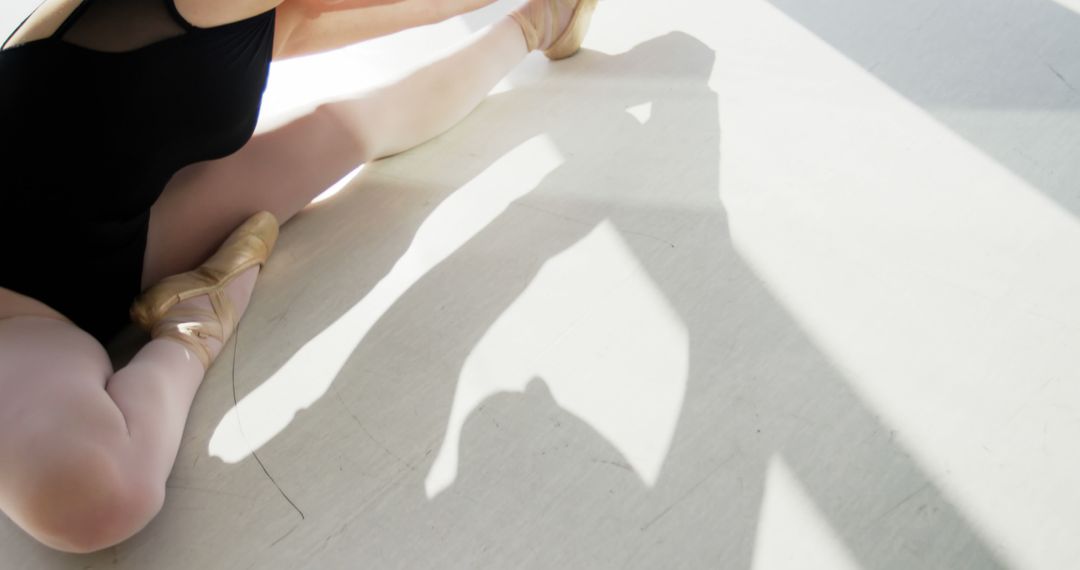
[170,33,1003,569]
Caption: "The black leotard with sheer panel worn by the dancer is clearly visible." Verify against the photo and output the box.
[0,0,274,340]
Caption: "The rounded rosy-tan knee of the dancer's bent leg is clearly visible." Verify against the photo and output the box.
[9,445,164,553]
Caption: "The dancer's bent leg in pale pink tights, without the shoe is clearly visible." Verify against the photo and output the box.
[0,276,254,553]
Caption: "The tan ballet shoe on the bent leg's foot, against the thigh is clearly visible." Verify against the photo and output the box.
[131,212,278,368]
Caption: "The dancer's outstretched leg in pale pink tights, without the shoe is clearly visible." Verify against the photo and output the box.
[143,9,568,280]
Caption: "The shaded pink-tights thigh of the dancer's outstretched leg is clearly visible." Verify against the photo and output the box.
[143,108,362,288]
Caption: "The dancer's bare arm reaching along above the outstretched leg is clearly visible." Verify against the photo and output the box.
[274,0,496,58]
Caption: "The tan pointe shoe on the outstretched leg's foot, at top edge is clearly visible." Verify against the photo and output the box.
[510,0,597,60]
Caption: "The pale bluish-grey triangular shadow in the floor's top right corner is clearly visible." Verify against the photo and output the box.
[769,0,1080,217]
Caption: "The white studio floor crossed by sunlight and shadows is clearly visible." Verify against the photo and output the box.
[0,0,1080,570]
